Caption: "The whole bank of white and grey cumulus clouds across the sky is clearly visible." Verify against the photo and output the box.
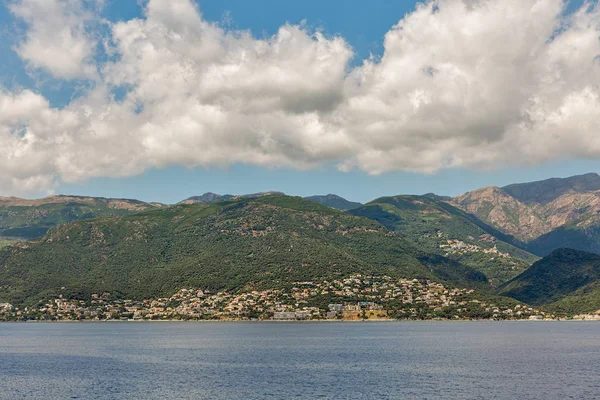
[0,0,600,192]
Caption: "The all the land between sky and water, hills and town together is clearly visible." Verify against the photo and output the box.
[0,174,600,320]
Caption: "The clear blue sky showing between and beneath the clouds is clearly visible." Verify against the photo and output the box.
[0,0,600,203]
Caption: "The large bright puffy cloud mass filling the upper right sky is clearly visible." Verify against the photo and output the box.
[338,0,600,173]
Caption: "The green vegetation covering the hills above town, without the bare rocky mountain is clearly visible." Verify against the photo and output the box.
[0,194,600,317]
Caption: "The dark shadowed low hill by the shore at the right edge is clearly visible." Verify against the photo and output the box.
[500,249,600,314]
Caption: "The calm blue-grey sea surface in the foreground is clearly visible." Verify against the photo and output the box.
[0,322,600,399]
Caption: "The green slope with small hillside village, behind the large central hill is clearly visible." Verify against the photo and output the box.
[349,196,537,285]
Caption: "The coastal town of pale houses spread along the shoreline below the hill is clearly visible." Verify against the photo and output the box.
[0,275,555,321]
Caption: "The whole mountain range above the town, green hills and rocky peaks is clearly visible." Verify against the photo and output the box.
[0,174,600,314]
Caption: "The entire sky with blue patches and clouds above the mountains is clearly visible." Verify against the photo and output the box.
[0,0,600,203]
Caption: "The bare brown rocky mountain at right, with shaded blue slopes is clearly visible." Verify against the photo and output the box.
[449,173,600,256]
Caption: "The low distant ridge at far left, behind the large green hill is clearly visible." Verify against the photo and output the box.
[0,195,163,240]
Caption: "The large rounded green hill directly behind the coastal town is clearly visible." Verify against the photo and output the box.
[0,195,486,304]
